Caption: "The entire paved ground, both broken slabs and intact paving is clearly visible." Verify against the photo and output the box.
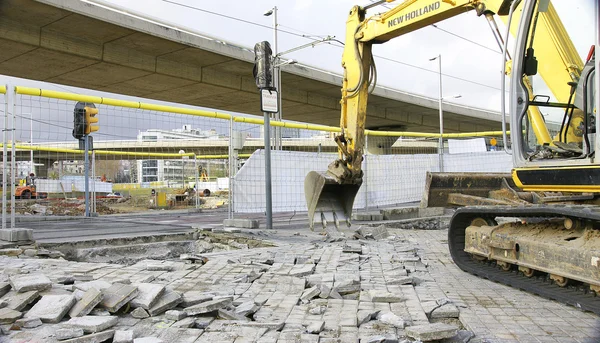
[0,224,600,343]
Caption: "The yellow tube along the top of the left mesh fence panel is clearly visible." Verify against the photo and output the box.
[15,86,231,120]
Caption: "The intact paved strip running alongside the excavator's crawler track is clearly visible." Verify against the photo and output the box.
[399,230,600,343]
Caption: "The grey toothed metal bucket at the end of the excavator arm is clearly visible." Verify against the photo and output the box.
[304,171,360,231]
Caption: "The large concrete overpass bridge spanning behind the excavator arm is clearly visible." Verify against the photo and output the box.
[0,0,500,132]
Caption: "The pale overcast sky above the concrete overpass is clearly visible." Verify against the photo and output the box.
[0,0,596,139]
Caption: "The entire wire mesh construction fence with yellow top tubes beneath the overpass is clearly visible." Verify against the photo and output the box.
[0,86,512,227]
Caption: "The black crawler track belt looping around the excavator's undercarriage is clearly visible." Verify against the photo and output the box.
[448,206,600,315]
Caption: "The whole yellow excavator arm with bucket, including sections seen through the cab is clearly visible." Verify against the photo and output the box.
[304,0,583,229]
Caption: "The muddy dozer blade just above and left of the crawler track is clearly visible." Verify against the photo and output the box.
[421,172,514,207]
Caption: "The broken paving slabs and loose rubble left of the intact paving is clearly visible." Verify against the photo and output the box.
[0,226,470,343]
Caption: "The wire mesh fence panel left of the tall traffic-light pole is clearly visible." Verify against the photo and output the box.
[6,87,230,224]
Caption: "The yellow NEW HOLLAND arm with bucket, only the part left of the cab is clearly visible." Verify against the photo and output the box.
[304,0,510,229]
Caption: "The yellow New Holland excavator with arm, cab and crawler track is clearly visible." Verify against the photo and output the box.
[305,0,600,314]
